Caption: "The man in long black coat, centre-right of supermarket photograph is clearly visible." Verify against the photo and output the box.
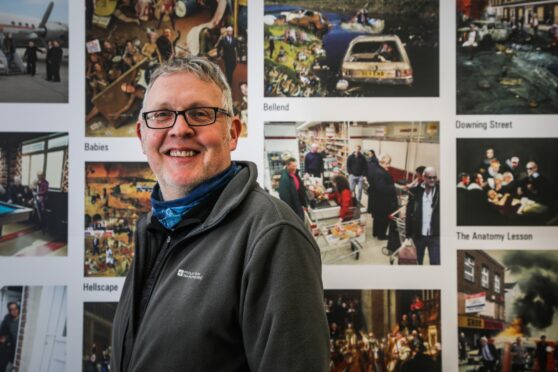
[372,155,397,240]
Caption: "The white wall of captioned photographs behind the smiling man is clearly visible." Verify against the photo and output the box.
[0,0,558,372]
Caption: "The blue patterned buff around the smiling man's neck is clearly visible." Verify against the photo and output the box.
[151,162,240,230]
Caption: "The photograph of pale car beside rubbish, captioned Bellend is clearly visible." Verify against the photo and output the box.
[264,0,439,97]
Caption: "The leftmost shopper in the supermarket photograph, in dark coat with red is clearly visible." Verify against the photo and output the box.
[277,158,306,221]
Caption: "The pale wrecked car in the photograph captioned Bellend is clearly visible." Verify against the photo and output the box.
[338,35,413,89]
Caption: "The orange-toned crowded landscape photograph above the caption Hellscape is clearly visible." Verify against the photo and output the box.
[84,162,156,276]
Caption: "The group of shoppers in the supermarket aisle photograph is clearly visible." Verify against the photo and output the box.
[278,143,440,265]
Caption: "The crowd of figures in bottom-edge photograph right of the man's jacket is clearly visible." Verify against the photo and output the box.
[324,296,441,372]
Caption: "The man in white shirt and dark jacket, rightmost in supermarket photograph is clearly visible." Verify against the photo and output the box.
[405,167,440,265]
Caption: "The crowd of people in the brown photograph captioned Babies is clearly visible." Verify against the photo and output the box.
[86,0,246,127]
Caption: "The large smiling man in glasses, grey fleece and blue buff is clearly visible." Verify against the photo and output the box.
[111,56,329,372]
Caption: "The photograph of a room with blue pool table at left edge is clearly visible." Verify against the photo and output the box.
[0,132,68,256]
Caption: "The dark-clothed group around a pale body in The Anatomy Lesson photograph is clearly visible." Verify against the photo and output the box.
[457,148,556,225]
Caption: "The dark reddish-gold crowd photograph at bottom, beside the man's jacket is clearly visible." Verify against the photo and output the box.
[324,289,442,372]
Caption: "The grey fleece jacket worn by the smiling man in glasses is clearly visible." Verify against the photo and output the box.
[111,162,329,372]
